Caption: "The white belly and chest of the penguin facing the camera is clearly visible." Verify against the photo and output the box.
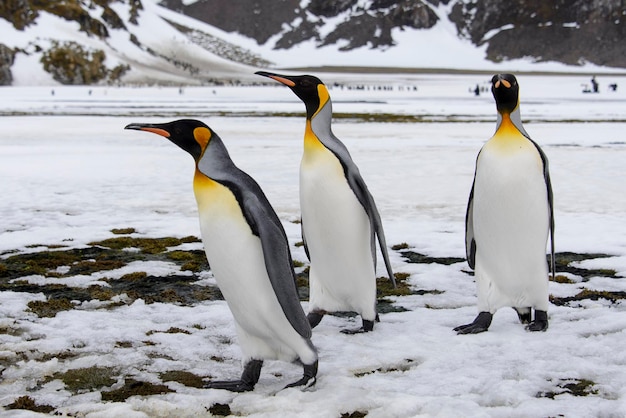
[473,134,550,310]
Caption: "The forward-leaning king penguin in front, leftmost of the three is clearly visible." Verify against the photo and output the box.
[125,119,318,392]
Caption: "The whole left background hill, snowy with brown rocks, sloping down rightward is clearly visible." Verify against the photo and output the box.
[0,0,268,85]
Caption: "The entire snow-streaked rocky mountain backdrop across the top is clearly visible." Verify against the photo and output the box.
[0,0,626,85]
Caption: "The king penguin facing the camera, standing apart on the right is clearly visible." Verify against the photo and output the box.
[454,74,555,334]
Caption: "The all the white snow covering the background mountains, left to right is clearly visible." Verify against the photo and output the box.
[0,0,616,86]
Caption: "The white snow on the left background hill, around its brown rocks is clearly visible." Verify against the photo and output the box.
[0,1,265,86]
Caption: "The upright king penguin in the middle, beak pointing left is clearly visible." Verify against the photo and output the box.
[256,71,395,334]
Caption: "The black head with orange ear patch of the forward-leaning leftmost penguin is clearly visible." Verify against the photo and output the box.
[124,119,213,161]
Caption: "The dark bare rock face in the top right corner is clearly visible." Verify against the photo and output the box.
[450,0,626,67]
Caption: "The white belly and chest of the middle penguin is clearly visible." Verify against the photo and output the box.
[300,136,376,319]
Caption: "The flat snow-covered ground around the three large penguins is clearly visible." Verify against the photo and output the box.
[0,74,626,417]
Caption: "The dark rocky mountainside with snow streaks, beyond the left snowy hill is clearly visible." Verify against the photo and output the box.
[161,0,626,67]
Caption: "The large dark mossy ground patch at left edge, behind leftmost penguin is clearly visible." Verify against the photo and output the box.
[0,233,223,308]
